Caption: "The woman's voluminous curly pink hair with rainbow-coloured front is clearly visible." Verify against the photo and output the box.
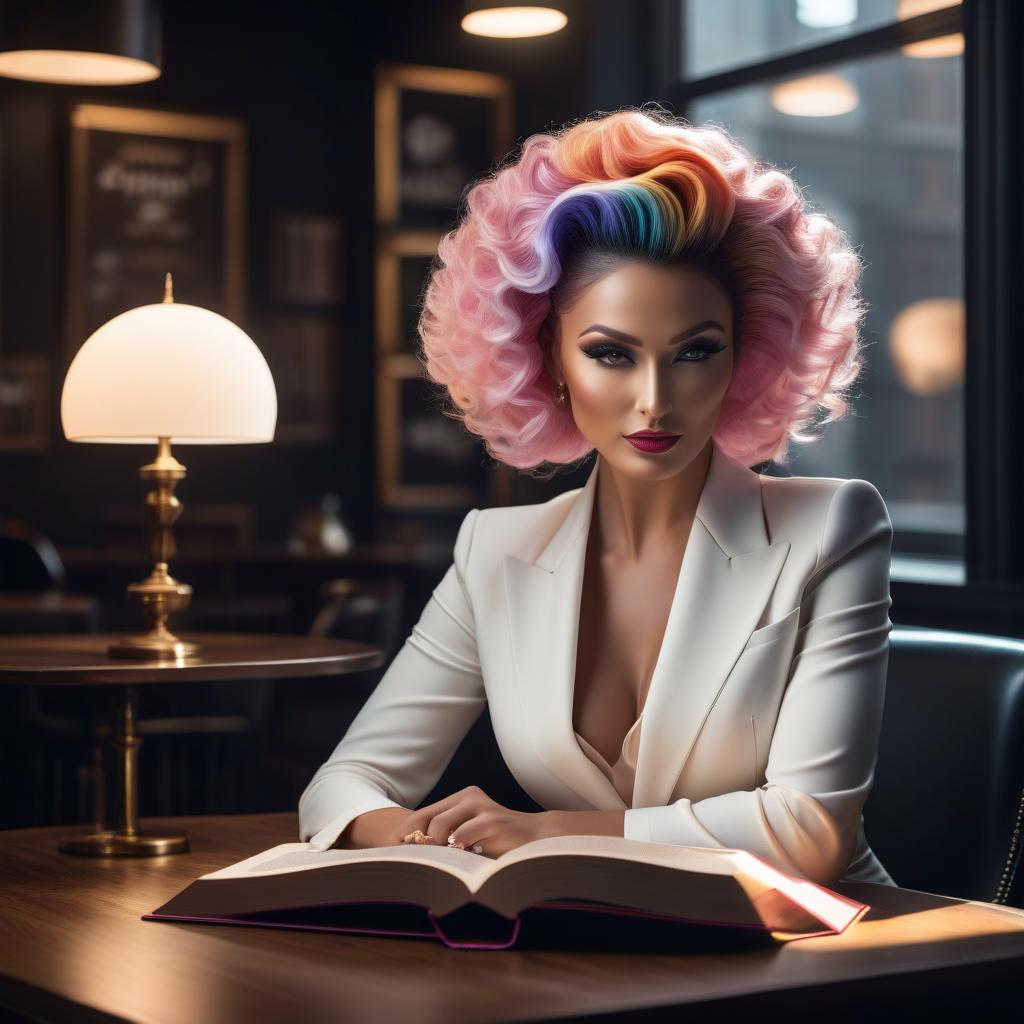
[419,104,865,469]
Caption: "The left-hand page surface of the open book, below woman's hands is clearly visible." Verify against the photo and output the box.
[200,843,498,890]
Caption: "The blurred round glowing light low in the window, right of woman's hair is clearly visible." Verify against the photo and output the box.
[889,298,966,395]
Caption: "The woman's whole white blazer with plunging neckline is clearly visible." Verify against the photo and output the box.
[299,442,894,885]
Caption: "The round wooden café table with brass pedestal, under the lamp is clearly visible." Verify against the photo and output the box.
[0,633,383,857]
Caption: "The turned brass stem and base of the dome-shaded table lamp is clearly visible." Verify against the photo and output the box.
[108,437,202,659]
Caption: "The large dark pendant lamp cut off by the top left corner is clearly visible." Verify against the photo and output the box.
[0,0,161,85]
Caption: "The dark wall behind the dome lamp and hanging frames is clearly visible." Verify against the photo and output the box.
[0,0,622,546]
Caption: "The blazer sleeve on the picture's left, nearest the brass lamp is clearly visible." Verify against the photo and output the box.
[299,509,486,850]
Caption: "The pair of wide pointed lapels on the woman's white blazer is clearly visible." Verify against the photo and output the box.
[505,444,790,809]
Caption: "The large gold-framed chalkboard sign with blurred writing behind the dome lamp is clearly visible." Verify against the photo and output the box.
[68,103,246,358]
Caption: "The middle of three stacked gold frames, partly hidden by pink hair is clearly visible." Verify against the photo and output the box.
[375,230,443,359]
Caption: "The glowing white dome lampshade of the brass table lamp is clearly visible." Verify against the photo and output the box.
[60,302,278,444]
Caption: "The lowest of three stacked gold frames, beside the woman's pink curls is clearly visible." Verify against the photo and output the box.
[377,355,495,509]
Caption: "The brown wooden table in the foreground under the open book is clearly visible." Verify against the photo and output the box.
[0,813,1024,1024]
